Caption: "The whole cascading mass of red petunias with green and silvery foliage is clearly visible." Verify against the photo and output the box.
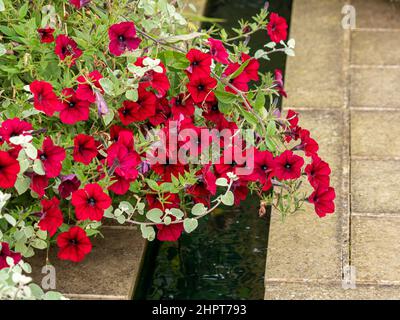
[0,0,335,268]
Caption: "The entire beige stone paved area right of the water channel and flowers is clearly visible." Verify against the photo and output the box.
[265,0,400,299]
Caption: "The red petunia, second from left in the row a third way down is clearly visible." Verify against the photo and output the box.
[60,88,90,124]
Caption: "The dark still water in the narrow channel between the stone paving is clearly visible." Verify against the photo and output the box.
[134,0,291,300]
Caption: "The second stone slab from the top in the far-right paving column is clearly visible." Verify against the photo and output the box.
[351,31,400,65]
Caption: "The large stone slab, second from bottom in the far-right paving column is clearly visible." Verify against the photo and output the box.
[351,218,400,282]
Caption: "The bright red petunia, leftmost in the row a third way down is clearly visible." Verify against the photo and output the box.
[29,80,62,117]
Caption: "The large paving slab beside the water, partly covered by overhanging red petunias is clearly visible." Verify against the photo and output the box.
[265,110,343,287]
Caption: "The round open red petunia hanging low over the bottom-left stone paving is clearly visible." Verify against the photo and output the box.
[57,226,92,262]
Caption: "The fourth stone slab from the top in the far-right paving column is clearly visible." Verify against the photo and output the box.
[351,110,400,158]
